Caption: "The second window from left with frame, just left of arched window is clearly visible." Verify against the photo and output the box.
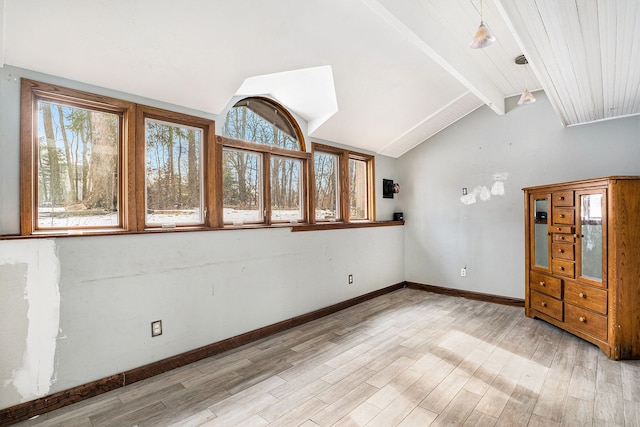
[136,106,215,228]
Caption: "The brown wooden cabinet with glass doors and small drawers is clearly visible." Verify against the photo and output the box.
[524,176,640,359]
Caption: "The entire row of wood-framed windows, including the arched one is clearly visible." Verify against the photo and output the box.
[20,79,375,235]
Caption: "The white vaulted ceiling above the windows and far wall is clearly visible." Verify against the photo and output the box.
[0,0,640,157]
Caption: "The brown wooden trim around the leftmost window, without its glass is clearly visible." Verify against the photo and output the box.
[20,79,136,235]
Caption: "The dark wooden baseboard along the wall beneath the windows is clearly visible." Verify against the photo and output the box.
[0,282,405,427]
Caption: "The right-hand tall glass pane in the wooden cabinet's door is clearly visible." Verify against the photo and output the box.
[578,190,606,284]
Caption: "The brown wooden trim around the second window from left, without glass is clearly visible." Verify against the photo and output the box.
[135,105,220,230]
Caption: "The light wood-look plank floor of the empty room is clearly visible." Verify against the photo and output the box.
[12,289,640,427]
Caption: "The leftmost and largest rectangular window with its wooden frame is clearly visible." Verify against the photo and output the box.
[21,80,135,234]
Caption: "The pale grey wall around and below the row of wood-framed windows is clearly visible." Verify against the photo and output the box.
[0,67,404,408]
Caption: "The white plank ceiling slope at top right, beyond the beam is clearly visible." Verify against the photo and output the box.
[497,0,640,126]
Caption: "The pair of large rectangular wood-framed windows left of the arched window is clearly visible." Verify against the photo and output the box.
[20,79,219,235]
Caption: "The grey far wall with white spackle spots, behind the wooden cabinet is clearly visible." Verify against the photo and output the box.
[397,92,640,298]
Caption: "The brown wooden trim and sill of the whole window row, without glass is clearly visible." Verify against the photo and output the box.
[16,79,376,240]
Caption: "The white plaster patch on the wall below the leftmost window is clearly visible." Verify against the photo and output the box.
[0,239,60,402]
